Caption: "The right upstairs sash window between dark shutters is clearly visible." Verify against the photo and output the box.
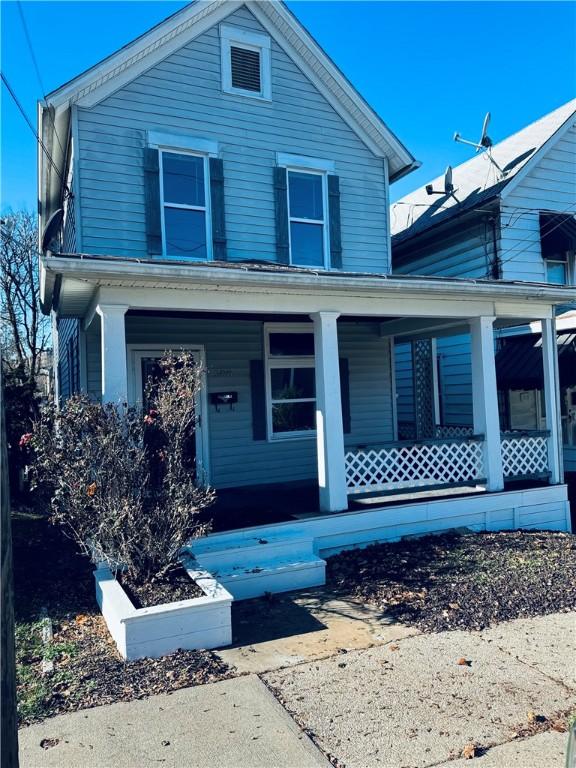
[288,170,326,267]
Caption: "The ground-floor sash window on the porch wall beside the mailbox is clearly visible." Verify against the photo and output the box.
[266,328,316,439]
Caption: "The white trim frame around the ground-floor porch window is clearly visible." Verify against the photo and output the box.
[264,323,317,443]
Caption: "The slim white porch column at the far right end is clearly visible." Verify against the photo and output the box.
[542,319,564,485]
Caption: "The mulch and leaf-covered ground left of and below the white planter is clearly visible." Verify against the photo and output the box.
[13,513,232,725]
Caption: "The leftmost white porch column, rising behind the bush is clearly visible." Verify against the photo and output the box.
[96,304,128,404]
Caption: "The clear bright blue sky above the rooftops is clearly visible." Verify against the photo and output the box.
[0,0,576,210]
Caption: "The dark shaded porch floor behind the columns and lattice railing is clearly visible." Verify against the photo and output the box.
[203,480,547,533]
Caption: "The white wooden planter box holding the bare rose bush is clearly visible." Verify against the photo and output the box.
[94,566,233,660]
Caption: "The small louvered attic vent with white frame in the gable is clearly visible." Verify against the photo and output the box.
[220,24,272,100]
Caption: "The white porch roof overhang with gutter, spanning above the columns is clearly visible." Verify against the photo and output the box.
[41,254,576,323]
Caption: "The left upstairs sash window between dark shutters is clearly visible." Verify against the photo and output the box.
[160,151,209,260]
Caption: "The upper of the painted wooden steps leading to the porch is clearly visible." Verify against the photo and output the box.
[189,536,315,573]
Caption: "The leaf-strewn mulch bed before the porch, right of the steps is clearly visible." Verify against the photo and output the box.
[327,531,576,632]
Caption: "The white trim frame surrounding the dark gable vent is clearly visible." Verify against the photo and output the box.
[220,24,272,101]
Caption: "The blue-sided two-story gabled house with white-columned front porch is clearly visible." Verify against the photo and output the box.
[39,0,576,584]
